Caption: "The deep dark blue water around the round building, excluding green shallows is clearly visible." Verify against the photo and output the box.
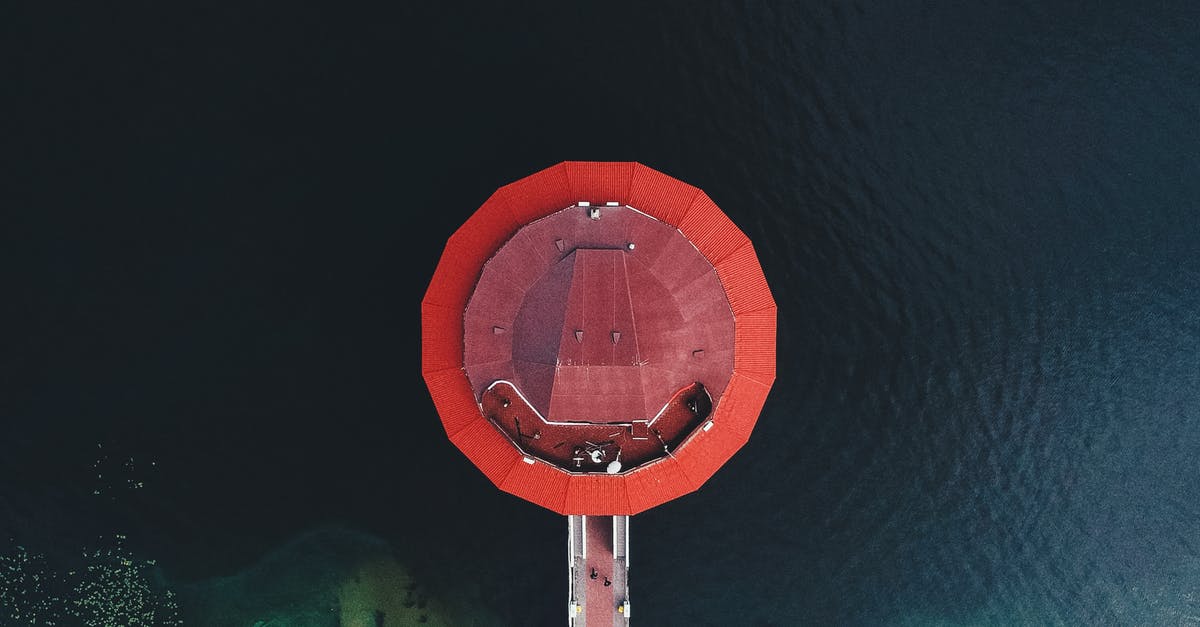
[0,1,1200,626]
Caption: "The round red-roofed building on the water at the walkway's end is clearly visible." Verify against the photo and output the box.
[421,161,775,515]
